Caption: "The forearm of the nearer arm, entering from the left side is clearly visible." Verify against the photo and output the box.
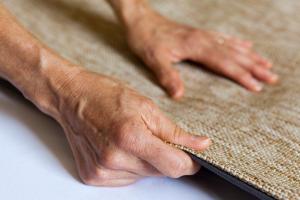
[0,4,82,118]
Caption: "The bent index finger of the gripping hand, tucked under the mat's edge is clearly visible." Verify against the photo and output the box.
[127,127,199,178]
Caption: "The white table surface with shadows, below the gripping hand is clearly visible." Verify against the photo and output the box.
[0,80,255,200]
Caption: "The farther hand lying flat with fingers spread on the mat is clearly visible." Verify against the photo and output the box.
[128,10,278,98]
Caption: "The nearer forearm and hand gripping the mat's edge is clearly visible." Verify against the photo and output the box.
[0,4,210,186]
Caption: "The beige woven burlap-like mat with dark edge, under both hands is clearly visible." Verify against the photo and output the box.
[2,0,300,199]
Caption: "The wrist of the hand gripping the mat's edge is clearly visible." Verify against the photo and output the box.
[29,48,86,119]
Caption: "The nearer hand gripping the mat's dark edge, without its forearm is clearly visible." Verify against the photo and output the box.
[52,70,210,186]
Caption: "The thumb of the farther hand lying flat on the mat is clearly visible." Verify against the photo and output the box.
[149,57,184,99]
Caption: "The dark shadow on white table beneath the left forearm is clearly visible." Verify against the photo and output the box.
[0,79,80,181]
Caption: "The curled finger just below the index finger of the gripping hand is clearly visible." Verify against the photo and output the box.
[98,149,162,176]
